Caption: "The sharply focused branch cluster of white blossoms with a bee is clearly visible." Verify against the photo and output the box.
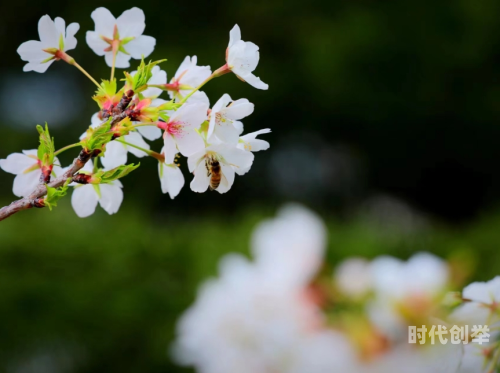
[0,8,270,218]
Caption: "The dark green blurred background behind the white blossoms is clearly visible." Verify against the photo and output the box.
[0,0,500,373]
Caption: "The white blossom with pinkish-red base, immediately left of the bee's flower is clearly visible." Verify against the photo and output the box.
[159,103,208,164]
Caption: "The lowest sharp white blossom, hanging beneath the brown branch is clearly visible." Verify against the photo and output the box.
[71,162,123,218]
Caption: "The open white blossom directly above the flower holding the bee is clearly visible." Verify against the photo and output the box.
[207,93,254,144]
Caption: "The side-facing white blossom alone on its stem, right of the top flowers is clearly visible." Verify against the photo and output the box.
[226,25,269,89]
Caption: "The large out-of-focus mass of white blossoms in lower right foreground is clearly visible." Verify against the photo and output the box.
[172,205,500,373]
